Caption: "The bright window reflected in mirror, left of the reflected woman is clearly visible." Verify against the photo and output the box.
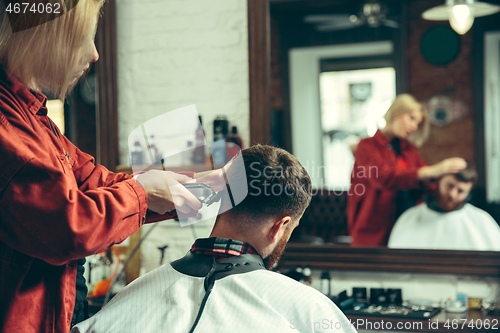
[319,67,396,191]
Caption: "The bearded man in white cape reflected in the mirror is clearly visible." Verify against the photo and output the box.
[389,166,500,251]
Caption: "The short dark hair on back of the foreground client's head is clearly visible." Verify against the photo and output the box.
[227,145,312,219]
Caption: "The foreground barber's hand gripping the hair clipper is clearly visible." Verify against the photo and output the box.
[134,170,202,215]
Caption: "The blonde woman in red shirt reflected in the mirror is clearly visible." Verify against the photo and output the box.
[347,94,466,246]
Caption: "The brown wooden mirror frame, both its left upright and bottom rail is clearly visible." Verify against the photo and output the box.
[247,0,500,277]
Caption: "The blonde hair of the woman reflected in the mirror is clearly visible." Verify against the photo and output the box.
[384,94,429,147]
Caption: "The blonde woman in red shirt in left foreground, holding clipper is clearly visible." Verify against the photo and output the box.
[0,0,220,333]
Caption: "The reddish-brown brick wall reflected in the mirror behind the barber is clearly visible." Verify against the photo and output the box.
[407,0,475,163]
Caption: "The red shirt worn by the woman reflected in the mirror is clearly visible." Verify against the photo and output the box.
[347,131,427,246]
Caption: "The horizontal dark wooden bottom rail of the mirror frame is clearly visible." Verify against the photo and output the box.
[279,243,500,277]
